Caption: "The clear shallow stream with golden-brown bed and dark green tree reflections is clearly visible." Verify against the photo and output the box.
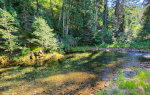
[0,52,149,95]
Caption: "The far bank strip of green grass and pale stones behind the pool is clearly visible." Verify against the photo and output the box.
[72,42,150,53]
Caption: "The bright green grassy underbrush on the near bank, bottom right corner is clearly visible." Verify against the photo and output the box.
[97,70,150,95]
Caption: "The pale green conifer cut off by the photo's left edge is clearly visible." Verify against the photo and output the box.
[0,9,19,52]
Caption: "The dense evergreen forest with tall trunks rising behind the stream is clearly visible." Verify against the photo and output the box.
[0,0,150,55]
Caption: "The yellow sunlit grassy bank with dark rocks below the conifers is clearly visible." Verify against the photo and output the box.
[0,51,64,67]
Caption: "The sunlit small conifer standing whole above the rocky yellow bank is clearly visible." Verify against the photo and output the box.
[31,17,58,51]
